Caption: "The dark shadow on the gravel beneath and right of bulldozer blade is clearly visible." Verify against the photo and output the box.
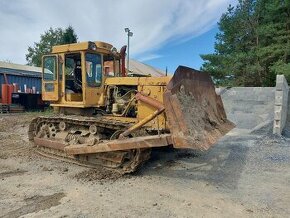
[138,136,254,189]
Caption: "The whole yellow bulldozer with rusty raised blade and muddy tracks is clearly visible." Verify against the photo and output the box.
[28,41,234,173]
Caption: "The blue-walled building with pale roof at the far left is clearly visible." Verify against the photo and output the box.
[0,61,41,96]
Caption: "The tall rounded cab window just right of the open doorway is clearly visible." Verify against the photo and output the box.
[86,53,102,87]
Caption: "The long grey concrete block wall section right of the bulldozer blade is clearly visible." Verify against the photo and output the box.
[220,87,275,130]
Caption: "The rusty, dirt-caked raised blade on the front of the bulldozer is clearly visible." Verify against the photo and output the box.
[164,66,235,150]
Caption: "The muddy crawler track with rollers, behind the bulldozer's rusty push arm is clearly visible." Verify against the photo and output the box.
[28,116,150,174]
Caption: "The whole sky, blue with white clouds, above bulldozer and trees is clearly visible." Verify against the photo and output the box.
[0,0,236,72]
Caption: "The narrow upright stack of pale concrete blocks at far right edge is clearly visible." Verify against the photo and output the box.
[273,75,289,135]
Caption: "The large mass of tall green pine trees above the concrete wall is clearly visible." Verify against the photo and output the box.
[201,0,290,86]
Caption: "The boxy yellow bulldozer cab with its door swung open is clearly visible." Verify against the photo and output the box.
[42,42,121,108]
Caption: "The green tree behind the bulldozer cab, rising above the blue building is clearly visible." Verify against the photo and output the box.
[26,26,78,67]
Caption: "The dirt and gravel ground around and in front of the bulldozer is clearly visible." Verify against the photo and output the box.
[0,114,290,217]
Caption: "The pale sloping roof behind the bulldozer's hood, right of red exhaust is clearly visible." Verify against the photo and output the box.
[126,59,166,77]
